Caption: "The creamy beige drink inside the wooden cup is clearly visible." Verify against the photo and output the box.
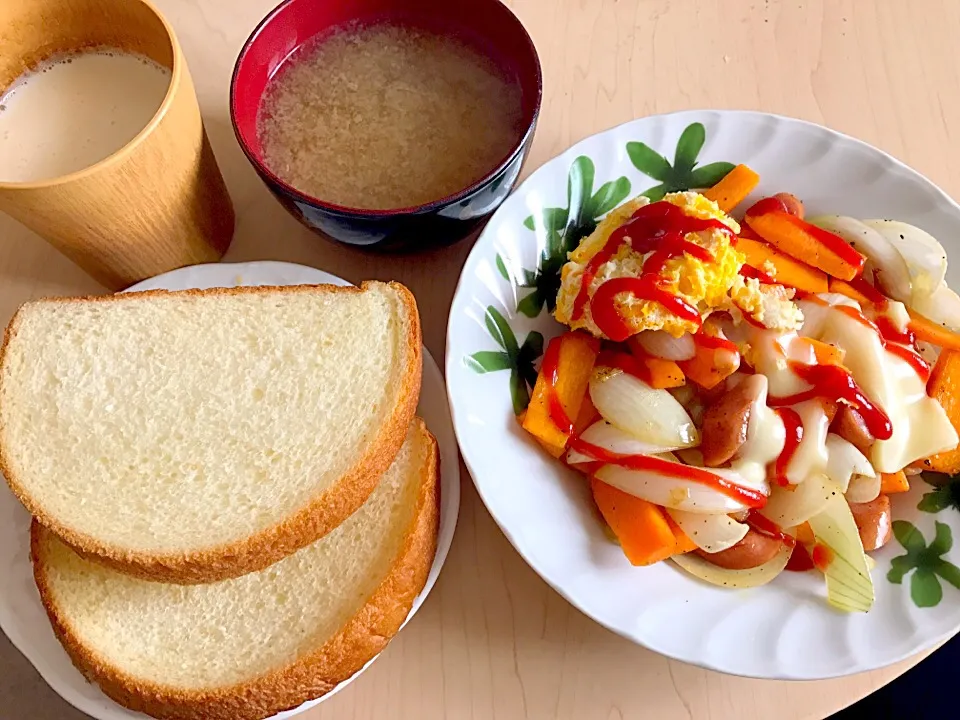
[0,49,170,182]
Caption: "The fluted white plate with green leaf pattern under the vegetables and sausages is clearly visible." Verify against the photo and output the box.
[446,111,960,679]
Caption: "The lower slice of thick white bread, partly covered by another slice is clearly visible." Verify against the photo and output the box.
[31,419,439,720]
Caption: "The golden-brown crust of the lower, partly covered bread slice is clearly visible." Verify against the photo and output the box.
[30,418,440,720]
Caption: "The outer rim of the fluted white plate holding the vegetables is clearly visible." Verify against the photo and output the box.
[444,108,960,681]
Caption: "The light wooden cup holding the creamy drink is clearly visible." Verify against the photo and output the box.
[0,0,234,290]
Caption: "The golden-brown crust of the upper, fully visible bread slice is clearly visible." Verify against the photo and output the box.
[0,282,423,585]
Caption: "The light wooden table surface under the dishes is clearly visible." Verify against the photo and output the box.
[0,0,960,720]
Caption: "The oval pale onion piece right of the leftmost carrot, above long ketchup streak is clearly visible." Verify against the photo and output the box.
[590,367,700,448]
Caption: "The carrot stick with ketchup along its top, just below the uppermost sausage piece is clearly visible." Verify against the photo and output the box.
[745,198,866,280]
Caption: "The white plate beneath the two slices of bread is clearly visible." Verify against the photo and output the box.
[0,262,460,720]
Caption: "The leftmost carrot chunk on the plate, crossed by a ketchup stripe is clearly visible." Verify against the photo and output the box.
[523,332,600,457]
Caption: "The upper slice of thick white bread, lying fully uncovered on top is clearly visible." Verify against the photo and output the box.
[0,283,421,584]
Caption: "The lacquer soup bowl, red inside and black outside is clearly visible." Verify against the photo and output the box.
[230,0,542,250]
